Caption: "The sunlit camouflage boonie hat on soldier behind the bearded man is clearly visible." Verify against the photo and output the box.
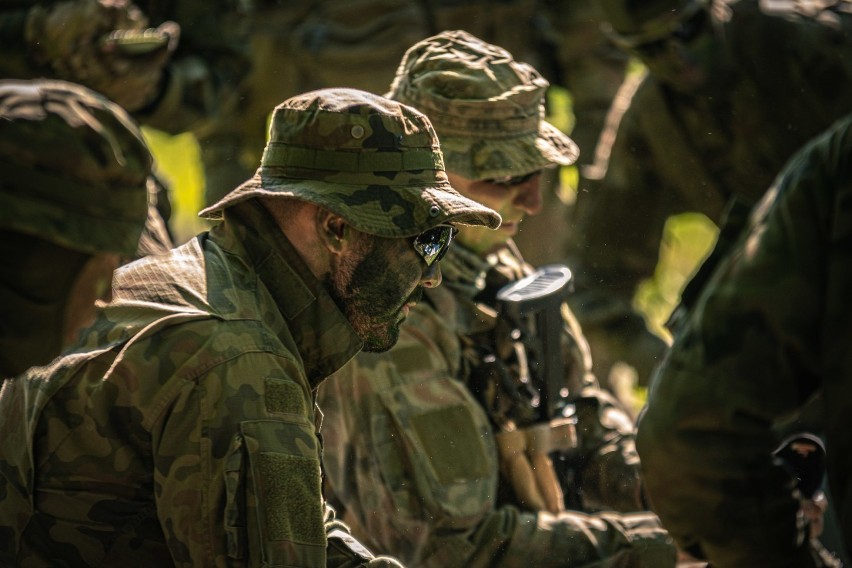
[387,31,579,180]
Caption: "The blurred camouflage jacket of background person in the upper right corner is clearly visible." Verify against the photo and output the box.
[568,0,852,325]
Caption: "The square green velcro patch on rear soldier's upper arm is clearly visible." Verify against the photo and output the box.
[411,406,491,484]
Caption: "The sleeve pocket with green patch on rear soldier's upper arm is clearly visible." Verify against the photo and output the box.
[370,378,497,528]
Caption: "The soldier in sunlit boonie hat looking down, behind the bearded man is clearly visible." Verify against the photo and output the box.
[319,31,675,567]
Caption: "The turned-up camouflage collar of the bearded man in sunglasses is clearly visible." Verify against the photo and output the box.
[225,199,363,388]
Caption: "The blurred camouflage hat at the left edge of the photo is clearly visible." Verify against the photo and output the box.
[0,80,153,256]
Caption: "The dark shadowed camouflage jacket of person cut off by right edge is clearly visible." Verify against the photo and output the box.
[638,113,852,566]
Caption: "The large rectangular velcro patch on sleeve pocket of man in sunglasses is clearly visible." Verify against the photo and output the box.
[257,452,325,545]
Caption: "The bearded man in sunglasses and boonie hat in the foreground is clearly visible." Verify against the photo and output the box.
[0,89,500,566]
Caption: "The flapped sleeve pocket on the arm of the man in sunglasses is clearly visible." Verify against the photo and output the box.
[238,415,326,567]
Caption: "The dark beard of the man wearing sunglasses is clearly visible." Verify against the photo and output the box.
[326,237,423,353]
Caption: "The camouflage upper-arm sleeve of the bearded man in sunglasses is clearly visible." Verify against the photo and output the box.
[152,353,326,566]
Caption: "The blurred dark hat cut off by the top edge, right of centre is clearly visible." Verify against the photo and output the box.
[603,0,708,50]
